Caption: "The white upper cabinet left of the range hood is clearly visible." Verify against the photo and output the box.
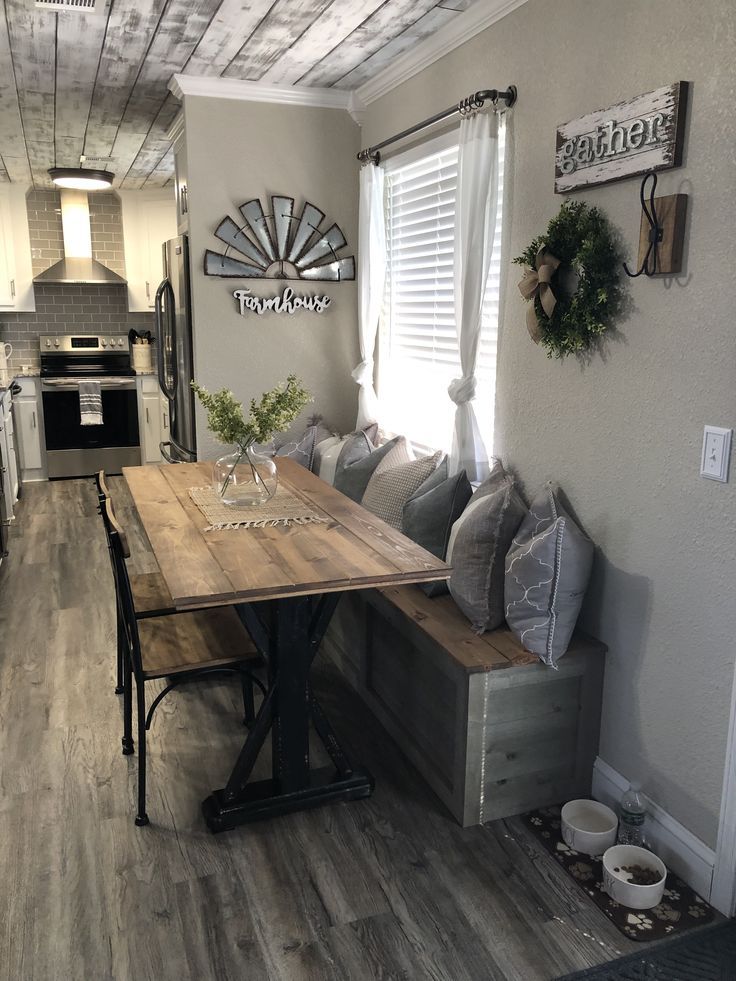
[0,184,36,312]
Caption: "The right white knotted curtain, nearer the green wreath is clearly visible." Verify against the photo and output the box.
[448,113,499,480]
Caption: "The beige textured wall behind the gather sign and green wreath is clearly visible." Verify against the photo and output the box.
[362,0,736,846]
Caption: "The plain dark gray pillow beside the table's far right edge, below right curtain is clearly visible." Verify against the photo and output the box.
[401,457,473,596]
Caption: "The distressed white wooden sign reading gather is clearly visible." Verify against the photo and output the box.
[555,82,688,194]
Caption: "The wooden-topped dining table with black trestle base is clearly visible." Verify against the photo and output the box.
[123,458,450,832]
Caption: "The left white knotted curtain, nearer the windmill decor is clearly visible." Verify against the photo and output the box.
[353,163,386,429]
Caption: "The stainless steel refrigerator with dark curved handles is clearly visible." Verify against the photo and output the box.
[155,235,197,463]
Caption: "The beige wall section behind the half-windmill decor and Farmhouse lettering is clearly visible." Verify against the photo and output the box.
[184,96,360,457]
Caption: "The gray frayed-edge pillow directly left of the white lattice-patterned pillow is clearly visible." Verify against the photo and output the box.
[447,462,526,633]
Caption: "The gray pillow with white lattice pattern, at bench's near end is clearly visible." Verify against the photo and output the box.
[505,484,593,666]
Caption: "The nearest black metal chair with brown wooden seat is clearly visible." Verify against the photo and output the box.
[101,498,263,826]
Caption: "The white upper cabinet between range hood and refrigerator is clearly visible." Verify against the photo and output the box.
[118,189,176,313]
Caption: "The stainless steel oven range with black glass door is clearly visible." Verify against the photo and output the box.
[41,335,141,478]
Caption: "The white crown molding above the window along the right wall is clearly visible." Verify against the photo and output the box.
[355,0,526,106]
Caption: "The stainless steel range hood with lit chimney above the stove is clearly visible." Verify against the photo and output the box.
[33,190,126,286]
